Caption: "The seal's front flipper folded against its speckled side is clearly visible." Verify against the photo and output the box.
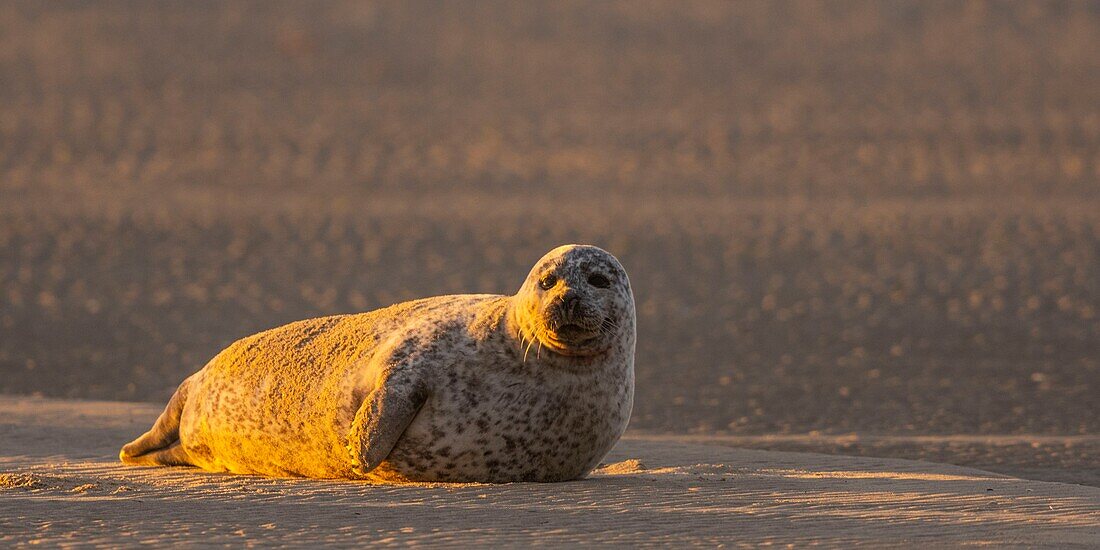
[348,365,428,476]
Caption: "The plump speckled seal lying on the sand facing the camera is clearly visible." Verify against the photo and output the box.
[120,244,637,483]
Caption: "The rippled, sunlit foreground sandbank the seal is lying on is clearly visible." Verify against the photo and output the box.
[0,396,1100,548]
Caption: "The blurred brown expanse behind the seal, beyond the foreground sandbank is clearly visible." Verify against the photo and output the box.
[0,0,1100,468]
